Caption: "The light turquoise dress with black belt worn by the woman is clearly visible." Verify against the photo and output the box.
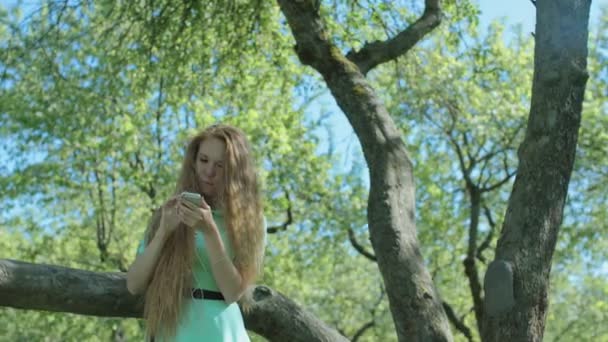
[137,211,249,342]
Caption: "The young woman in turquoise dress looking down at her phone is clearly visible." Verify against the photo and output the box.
[127,125,265,342]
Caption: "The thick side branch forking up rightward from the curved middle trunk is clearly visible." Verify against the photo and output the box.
[346,0,441,75]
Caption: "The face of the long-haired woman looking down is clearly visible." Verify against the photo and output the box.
[194,137,226,201]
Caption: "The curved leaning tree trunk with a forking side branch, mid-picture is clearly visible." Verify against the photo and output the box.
[278,0,452,341]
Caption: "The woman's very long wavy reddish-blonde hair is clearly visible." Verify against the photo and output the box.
[144,124,265,339]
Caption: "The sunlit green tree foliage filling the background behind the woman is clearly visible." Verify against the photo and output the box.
[0,1,608,341]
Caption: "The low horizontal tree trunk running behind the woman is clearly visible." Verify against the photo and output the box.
[0,259,347,342]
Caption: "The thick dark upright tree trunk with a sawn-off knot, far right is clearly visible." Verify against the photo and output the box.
[482,0,591,341]
